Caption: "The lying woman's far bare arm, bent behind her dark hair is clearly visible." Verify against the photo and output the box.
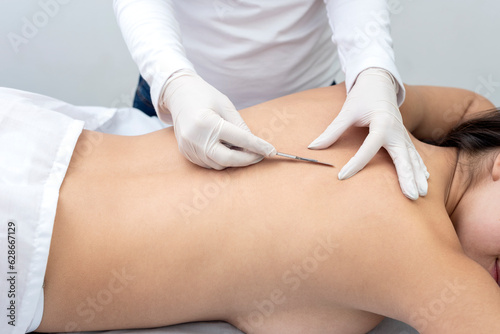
[400,85,494,140]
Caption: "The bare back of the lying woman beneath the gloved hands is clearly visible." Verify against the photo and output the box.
[39,86,496,333]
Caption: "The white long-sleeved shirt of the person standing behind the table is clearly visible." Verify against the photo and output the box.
[114,0,404,115]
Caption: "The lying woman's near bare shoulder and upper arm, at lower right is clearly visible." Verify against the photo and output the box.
[336,210,500,334]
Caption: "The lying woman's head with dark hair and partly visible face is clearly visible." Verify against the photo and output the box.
[440,110,500,283]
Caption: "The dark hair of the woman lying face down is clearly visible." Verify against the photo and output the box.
[433,108,500,156]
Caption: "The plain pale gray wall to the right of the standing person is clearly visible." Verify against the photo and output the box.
[389,0,500,106]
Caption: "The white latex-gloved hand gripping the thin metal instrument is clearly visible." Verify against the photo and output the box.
[160,70,276,170]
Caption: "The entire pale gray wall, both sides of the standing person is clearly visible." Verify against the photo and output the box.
[0,0,500,106]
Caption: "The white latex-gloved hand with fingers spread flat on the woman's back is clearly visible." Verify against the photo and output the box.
[309,68,429,200]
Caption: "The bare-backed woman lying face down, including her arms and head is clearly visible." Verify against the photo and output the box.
[37,81,500,333]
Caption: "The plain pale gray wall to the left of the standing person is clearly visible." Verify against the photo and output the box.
[0,0,138,106]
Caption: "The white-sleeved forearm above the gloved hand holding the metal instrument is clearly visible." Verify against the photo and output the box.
[113,0,193,111]
